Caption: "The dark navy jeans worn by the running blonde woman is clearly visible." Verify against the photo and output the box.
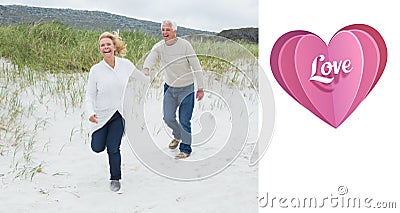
[91,111,124,180]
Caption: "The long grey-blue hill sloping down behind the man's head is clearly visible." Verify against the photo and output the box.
[0,5,215,36]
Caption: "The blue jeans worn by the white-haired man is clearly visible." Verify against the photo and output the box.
[163,84,194,154]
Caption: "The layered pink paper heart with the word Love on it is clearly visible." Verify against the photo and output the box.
[270,24,387,128]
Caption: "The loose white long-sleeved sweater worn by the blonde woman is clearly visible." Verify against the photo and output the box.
[85,57,139,132]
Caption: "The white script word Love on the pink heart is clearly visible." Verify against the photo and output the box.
[310,55,353,84]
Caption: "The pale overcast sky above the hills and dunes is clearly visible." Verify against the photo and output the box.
[0,0,258,32]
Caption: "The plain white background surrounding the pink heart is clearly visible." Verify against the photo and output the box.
[259,0,400,212]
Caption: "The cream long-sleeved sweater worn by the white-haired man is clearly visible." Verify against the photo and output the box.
[143,38,203,89]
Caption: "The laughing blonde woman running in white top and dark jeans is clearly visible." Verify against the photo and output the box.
[85,32,139,192]
